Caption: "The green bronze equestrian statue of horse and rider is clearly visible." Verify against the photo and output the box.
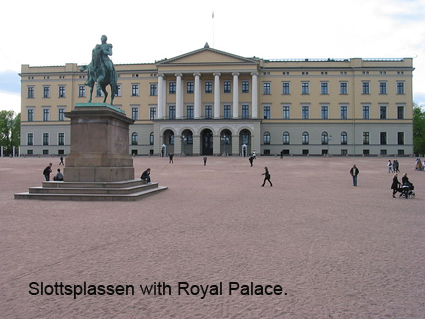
[80,35,118,105]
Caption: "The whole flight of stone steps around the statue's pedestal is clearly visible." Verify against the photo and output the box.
[15,179,167,201]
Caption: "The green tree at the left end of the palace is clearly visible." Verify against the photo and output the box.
[0,111,21,155]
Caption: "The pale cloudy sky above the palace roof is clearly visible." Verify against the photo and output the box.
[0,0,425,113]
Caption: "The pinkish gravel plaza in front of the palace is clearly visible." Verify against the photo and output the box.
[0,156,425,319]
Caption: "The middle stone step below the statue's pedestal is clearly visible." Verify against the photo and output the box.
[29,183,158,195]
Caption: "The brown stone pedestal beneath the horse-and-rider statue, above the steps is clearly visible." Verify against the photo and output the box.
[64,103,134,182]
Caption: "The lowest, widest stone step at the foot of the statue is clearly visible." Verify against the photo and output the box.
[15,186,167,201]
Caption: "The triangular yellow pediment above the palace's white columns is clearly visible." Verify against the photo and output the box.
[157,47,258,66]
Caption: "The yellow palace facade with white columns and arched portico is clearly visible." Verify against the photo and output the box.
[20,44,414,156]
